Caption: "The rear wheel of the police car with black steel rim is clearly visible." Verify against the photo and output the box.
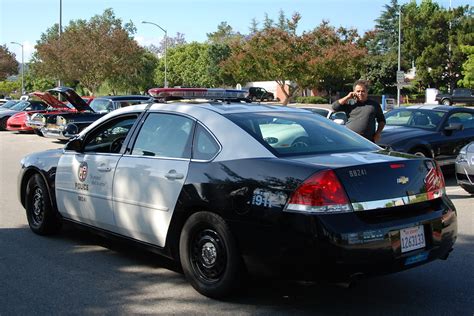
[179,212,244,298]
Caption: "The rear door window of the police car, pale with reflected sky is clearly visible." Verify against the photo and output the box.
[132,113,194,158]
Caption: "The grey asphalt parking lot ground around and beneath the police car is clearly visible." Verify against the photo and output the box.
[0,132,474,316]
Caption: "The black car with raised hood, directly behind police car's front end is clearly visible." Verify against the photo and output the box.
[42,87,153,140]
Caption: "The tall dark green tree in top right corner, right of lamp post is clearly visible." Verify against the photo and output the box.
[402,0,474,89]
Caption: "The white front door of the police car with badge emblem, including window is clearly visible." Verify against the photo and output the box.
[56,114,138,230]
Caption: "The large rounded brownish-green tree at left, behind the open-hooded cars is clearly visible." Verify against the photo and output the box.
[36,9,144,94]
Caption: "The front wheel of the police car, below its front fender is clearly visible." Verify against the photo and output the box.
[26,174,62,235]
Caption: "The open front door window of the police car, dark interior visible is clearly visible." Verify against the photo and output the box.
[84,114,138,154]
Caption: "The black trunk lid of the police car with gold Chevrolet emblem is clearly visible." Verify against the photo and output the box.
[290,152,441,210]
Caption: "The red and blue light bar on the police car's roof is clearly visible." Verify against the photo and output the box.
[148,88,248,99]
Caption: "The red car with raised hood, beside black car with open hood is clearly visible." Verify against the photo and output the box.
[7,92,93,135]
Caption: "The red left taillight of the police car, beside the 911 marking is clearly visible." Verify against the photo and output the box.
[285,170,352,214]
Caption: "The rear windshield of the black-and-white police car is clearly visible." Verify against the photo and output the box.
[226,112,380,156]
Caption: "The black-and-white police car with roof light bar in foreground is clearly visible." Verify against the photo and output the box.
[18,88,457,297]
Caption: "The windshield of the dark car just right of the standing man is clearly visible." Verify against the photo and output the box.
[385,109,445,130]
